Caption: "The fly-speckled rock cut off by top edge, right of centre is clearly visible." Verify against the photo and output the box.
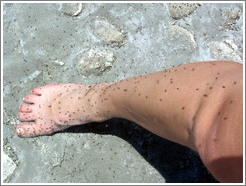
[168,3,202,19]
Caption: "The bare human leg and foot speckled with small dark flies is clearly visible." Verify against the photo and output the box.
[16,61,243,183]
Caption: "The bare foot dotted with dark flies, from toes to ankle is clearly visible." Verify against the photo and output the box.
[16,84,110,137]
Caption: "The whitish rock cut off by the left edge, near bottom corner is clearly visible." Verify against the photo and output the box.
[2,152,16,180]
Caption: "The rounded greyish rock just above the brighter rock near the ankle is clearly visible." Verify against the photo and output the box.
[94,18,126,47]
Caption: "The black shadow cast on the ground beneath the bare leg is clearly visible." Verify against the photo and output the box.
[63,118,218,183]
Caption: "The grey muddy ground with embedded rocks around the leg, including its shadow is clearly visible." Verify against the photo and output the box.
[1,3,243,183]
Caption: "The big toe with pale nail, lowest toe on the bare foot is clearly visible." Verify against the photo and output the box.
[16,123,54,138]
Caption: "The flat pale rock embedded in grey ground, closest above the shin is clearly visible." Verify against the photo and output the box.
[167,25,197,51]
